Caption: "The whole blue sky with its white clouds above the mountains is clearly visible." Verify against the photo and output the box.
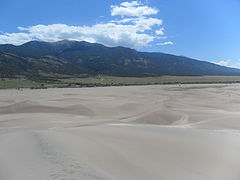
[0,0,240,67]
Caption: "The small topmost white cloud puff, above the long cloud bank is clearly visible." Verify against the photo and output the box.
[111,1,158,17]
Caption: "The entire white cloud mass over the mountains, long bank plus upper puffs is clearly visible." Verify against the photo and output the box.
[0,1,168,48]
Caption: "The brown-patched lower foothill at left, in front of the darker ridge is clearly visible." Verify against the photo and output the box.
[0,52,86,77]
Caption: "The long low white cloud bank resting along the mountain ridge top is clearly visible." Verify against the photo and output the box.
[0,23,154,48]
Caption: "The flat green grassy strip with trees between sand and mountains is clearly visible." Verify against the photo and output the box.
[0,76,240,89]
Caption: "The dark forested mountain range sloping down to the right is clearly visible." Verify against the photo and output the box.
[0,40,240,77]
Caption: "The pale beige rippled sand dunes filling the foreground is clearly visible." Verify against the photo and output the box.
[0,84,240,180]
